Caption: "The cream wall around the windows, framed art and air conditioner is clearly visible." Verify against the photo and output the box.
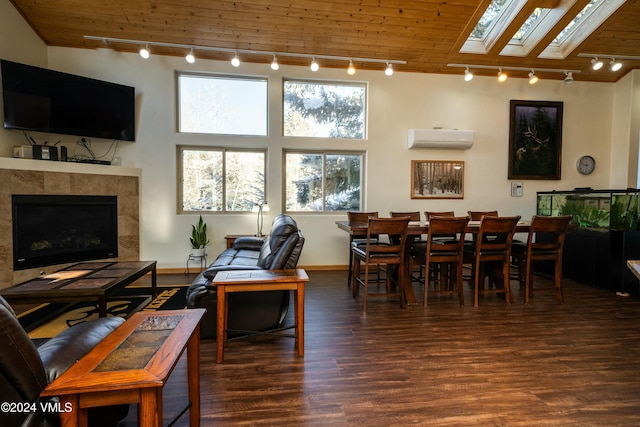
[0,0,630,268]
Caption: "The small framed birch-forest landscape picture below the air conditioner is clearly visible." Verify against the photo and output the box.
[411,160,464,199]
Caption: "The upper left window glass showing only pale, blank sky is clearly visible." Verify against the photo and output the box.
[178,73,267,136]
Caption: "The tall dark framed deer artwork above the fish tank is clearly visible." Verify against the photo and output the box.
[509,100,563,179]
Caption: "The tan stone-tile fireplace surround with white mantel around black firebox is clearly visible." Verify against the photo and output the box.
[0,157,142,288]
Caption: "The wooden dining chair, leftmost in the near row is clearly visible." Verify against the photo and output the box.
[351,217,409,312]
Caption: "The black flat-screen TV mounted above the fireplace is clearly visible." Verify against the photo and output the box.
[0,59,135,141]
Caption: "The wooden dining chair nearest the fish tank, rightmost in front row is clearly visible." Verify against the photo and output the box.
[511,215,573,305]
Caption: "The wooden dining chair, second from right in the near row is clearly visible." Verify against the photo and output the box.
[465,215,520,307]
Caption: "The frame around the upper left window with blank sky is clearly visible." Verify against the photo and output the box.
[175,70,269,137]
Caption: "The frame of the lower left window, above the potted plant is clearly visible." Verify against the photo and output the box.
[176,144,269,215]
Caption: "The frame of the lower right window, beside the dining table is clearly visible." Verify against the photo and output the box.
[282,149,367,215]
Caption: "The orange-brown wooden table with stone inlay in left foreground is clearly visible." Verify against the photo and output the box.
[40,308,206,427]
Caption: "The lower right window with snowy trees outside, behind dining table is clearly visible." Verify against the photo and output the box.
[284,152,364,212]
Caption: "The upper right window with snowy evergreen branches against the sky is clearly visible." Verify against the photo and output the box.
[283,80,366,139]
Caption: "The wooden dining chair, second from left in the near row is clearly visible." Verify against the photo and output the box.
[411,216,469,307]
